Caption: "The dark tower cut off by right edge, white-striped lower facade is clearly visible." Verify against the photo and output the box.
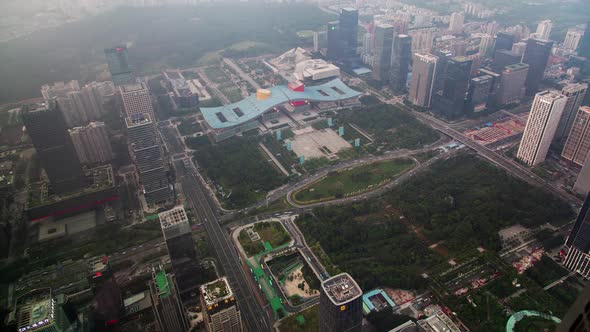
[563,195,590,279]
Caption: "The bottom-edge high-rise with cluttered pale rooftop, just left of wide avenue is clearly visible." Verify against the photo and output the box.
[200,277,243,332]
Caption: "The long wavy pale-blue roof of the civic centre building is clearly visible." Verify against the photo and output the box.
[201,79,361,129]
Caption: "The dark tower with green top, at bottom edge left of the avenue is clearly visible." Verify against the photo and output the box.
[150,266,189,332]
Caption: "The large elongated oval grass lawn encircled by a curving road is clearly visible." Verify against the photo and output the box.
[293,159,415,204]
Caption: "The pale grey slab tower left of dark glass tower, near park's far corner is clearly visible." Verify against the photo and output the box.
[408,53,438,107]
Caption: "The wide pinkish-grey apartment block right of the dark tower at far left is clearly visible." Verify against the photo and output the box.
[70,122,113,164]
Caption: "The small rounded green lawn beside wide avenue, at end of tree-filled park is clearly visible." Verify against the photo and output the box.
[238,221,291,257]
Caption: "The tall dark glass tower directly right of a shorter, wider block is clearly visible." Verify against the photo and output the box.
[522,38,553,96]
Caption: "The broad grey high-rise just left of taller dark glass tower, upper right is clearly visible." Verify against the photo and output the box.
[495,63,529,105]
